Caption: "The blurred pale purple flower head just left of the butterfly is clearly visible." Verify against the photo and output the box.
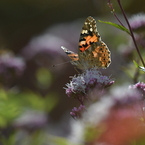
[21,34,69,60]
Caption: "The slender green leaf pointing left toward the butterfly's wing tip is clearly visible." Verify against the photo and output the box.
[98,20,130,35]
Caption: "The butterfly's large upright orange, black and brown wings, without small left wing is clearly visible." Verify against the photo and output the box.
[79,16,111,68]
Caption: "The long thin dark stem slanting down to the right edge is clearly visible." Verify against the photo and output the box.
[117,0,145,67]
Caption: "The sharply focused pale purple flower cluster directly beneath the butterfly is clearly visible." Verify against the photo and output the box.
[65,69,114,104]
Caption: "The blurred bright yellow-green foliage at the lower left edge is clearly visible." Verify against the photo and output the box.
[0,89,57,127]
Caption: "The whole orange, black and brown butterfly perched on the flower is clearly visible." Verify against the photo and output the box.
[61,16,111,70]
